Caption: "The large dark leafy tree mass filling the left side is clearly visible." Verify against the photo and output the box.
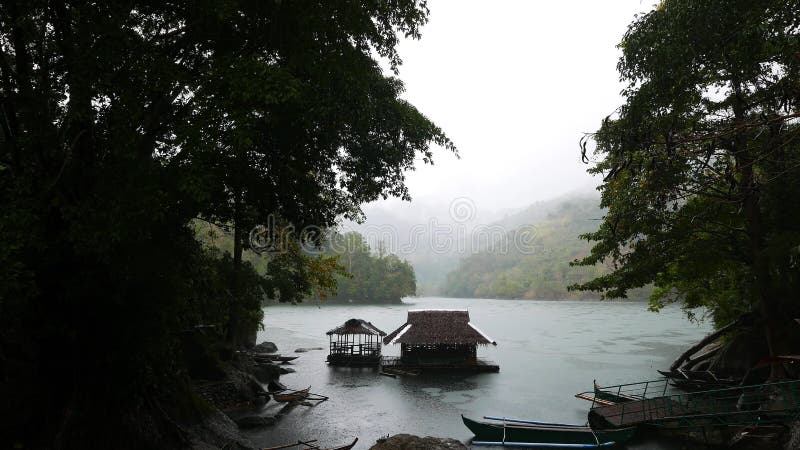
[0,0,454,448]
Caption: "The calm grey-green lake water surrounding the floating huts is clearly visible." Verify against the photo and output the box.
[248,298,710,449]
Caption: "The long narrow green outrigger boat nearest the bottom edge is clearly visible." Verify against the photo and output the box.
[461,415,636,448]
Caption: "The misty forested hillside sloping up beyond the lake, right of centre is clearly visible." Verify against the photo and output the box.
[444,197,647,299]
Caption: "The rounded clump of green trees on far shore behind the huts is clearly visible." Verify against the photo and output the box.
[324,232,417,303]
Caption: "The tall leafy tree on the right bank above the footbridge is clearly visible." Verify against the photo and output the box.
[573,0,800,375]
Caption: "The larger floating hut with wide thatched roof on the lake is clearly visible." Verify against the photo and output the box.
[383,309,500,372]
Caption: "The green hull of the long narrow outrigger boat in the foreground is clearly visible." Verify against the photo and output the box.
[462,416,636,445]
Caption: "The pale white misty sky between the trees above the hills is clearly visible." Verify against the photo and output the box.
[365,0,653,217]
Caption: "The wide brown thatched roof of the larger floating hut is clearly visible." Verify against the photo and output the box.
[383,309,497,345]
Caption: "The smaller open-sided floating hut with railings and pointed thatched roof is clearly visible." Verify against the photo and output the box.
[326,319,386,366]
